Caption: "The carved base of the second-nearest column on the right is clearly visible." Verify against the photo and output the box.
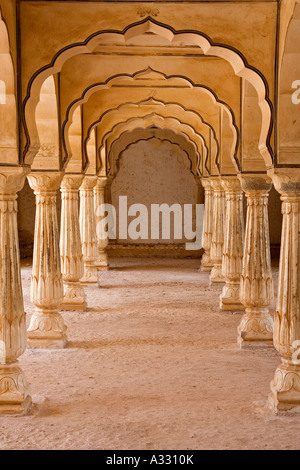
[237,308,273,348]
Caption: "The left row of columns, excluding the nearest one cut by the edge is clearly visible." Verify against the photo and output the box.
[27,172,107,348]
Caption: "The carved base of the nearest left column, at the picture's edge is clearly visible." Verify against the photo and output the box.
[0,362,31,415]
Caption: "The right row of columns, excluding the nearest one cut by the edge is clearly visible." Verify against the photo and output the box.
[202,176,273,347]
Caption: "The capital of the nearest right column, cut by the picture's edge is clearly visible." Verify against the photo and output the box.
[268,168,300,196]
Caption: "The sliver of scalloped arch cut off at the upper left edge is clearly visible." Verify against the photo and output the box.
[0,9,19,165]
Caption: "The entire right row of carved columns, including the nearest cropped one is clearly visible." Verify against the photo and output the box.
[201,173,300,412]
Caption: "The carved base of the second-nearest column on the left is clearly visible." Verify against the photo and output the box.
[27,310,67,348]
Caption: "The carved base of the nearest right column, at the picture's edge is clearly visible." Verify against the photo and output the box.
[268,359,300,413]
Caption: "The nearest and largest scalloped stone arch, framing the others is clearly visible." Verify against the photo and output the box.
[22,17,273,168]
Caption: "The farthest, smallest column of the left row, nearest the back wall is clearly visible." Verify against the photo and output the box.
[94,176,108,271]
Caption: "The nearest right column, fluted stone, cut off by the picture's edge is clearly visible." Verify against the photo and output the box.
[269,168,300,412]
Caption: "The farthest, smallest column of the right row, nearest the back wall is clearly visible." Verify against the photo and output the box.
[200,178,213,271]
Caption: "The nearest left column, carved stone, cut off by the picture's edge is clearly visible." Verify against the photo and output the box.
[0,167,31,414]
